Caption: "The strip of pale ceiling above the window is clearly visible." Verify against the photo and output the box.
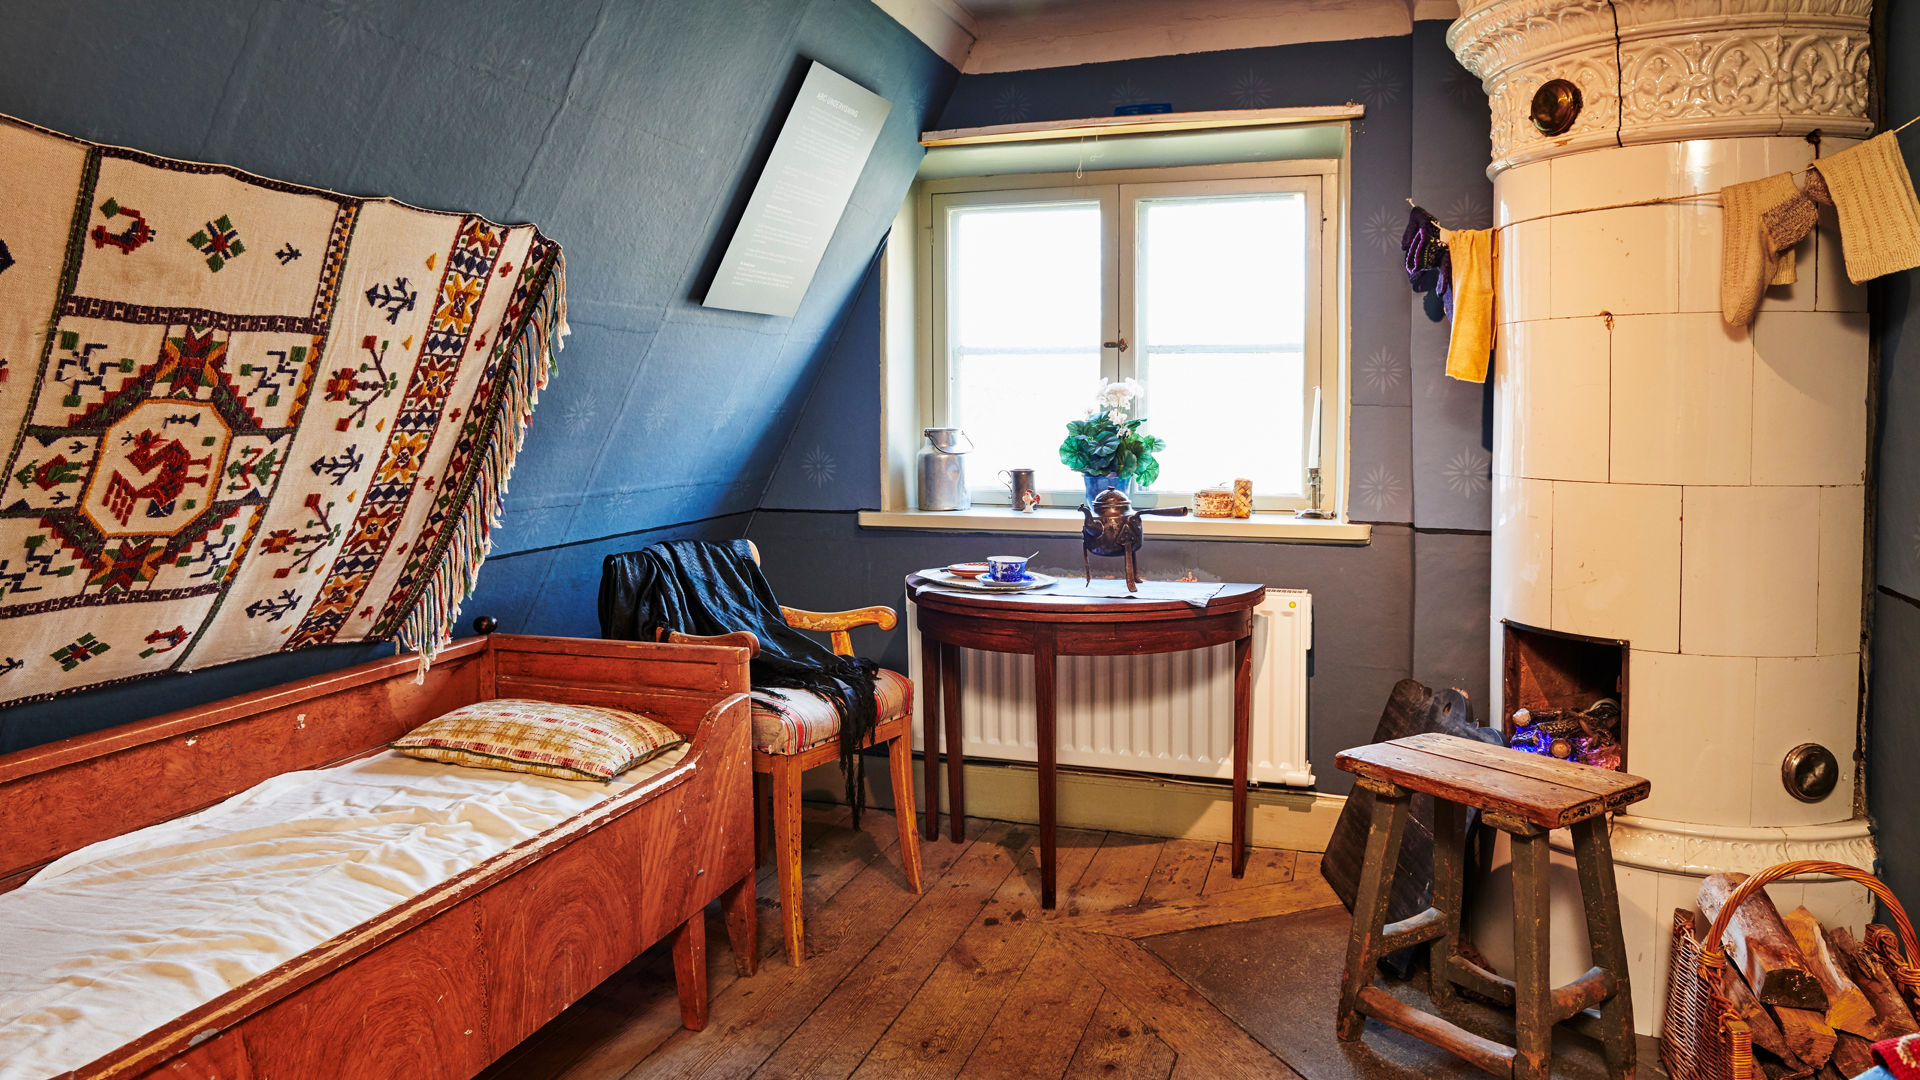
[874,0,1459,73]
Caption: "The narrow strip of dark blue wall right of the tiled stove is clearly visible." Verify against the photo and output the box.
[1866,4,1920,911]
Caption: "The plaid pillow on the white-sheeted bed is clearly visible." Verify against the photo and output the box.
[388,698,687,780]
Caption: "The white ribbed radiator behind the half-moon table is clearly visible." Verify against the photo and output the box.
[906,588,1313,788]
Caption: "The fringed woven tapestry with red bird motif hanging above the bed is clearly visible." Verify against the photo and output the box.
[0,117,566,705]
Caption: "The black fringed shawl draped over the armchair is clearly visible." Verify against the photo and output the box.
[599,540,879,822]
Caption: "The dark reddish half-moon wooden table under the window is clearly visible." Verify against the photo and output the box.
[906,575,1265,907]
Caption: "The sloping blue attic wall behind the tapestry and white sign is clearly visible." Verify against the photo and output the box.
[0,0,956,751]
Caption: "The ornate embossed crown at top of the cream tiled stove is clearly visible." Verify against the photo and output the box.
[1448,0,1872,175]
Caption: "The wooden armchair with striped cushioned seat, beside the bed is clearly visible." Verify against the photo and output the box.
[664,544,922,967]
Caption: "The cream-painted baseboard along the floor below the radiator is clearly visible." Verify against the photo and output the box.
[803,757,1346,851]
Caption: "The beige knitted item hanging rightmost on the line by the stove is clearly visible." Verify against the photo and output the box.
[1814,131,1920,284]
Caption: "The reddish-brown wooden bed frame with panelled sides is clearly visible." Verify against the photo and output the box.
[0,634,758,1080]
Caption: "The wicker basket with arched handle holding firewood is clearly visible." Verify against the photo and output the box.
[1661,859,1920,1080]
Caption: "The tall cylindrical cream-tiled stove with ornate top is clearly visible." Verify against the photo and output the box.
[1450,0,1874,1034]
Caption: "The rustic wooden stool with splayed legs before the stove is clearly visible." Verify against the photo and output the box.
[1334,734,1649,1080]
